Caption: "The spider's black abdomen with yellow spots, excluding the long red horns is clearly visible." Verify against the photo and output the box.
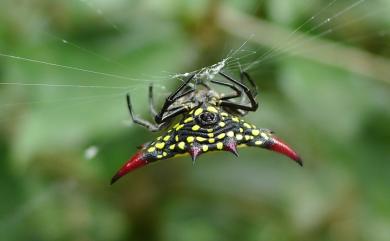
[142,104,270,162]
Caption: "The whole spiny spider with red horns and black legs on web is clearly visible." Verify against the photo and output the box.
[111,71,302,184]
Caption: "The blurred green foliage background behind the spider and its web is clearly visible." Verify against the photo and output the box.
[0,0,390,241]
